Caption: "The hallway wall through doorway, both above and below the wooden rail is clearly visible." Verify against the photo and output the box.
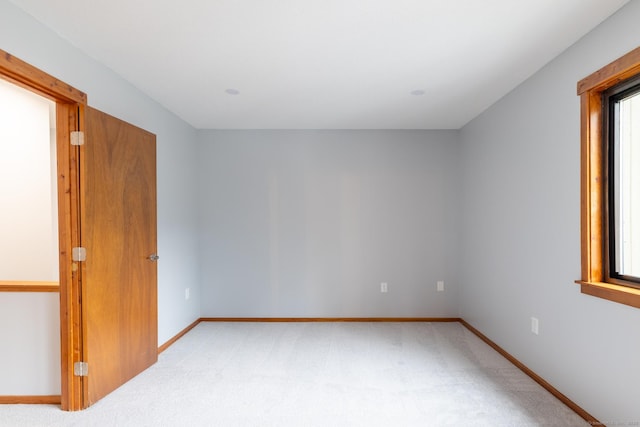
[0,72,60,395]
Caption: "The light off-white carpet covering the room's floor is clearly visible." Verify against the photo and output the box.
[0,322,589,427]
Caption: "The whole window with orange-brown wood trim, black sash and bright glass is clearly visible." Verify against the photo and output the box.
[577,48,640,308]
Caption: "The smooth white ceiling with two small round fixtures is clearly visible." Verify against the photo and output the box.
[7,0,628,129]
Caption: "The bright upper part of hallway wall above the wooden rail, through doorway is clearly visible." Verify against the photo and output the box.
[0,80,59,282]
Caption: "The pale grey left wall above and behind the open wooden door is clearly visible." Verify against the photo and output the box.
[0,0,200,348]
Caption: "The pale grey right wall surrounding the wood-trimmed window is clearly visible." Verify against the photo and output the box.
[460,0,640,425]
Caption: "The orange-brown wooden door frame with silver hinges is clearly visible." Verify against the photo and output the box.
[0,49,87,411]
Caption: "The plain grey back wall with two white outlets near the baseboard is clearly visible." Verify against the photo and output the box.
[198,131,459,317]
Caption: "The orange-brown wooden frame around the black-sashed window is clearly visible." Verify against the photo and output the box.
[576,47,640,308]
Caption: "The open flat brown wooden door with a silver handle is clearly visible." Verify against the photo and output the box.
[80,107,158,407]
